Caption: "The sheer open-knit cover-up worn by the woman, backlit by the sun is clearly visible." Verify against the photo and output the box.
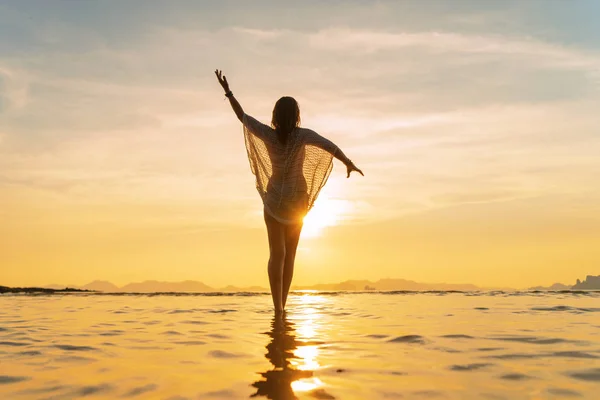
[242,114,339,224]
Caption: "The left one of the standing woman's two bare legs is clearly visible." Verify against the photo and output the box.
[265,211,285,313]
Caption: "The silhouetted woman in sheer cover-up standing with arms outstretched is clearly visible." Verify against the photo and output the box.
[215,70,364,314]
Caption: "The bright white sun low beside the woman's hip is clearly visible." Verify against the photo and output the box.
[301,195,350,238]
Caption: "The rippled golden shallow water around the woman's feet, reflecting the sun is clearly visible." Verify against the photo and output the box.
[0,292,600,400]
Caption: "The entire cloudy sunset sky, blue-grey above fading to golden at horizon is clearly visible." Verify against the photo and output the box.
[0,0,600,288]
